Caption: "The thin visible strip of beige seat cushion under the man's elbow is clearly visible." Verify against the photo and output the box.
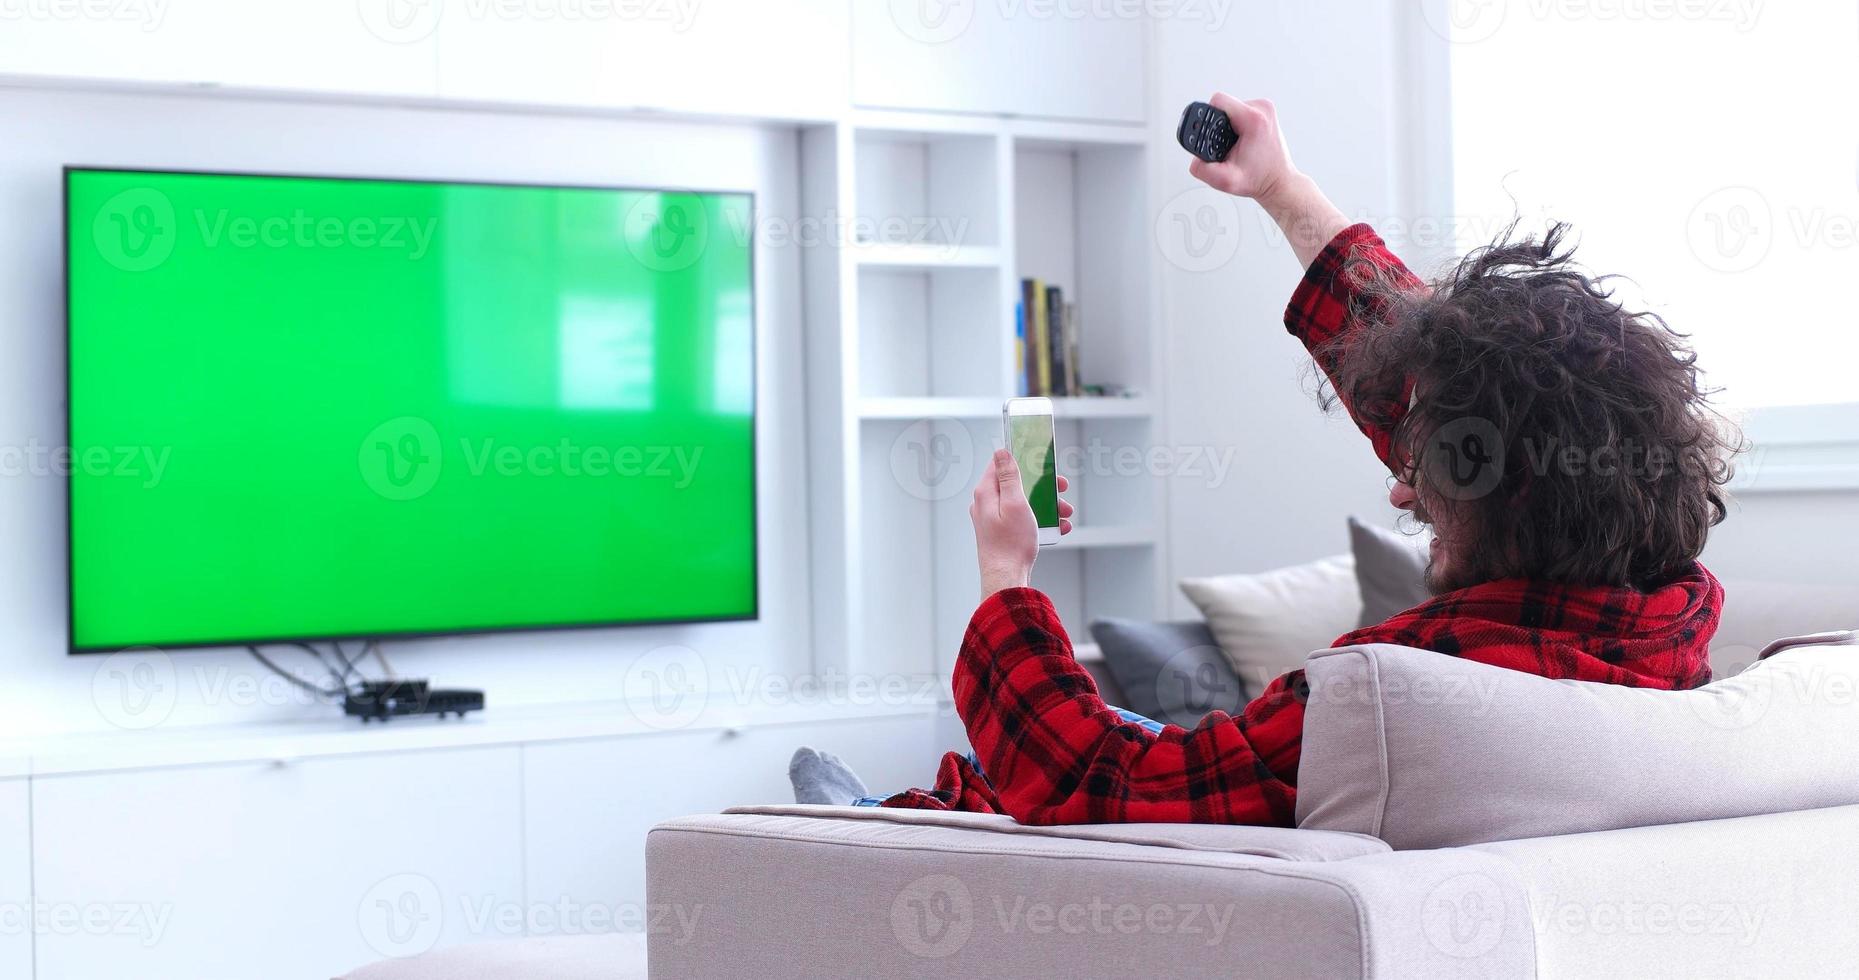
[723,803,1389,861]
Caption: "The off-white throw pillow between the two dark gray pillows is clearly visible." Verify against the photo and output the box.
[1180,554,1363,692]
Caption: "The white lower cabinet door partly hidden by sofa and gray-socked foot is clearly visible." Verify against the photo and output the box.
[522,714,939,932]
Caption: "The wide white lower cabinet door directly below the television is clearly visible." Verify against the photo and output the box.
[32,748,524,980]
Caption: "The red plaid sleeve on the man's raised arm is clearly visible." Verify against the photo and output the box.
[1285,225,1426,476]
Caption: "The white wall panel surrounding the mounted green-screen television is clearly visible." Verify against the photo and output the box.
[0,89,811,735]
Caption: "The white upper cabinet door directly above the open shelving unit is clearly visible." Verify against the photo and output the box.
[851,0,1147,123]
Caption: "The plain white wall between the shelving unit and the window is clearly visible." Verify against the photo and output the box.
[1151,0,1402,616]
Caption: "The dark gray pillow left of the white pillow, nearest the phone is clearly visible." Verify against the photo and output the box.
[1091,619,1251,729]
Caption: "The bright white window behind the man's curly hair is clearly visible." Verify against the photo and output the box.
[1430,0,1859,410]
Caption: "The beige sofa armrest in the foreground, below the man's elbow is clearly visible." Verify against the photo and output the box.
[645,811,1536,980]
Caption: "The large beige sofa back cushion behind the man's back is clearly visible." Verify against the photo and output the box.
[1298,636,1859,850]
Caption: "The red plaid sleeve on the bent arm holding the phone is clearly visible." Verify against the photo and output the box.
[956,588,1305,828]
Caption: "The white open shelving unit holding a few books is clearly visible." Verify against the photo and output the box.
[801,112,1166,679]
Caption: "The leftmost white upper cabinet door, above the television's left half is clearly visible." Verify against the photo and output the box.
[0,0,436,97]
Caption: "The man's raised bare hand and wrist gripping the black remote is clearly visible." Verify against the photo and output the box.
[1188,91,1350,266]
